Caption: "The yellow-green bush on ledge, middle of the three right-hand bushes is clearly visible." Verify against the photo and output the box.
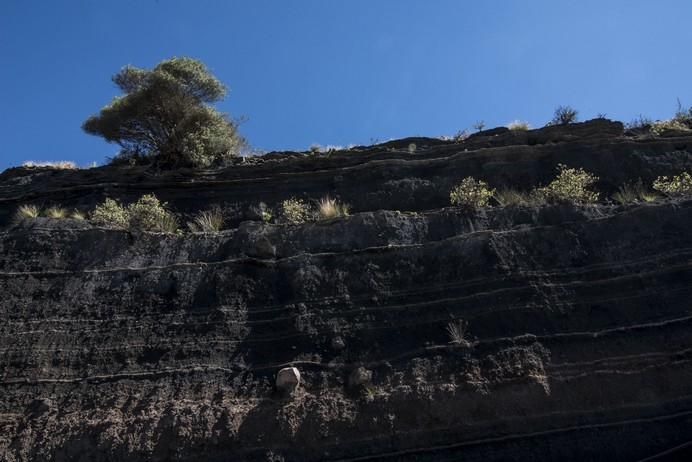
[536,164,598,204]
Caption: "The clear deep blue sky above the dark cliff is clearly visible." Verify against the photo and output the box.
[0,0,692,170]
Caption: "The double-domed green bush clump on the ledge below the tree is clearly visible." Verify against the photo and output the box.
[91,194,178,233]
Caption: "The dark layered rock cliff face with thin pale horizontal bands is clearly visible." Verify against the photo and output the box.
[0,120,692,461]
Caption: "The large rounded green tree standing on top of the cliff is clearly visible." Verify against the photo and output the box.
[82,58,245,167]
